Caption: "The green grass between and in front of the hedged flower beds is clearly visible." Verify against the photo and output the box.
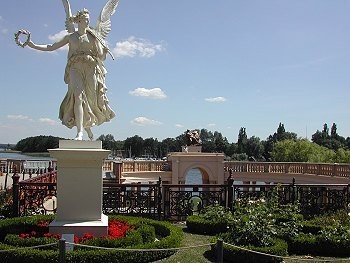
[154,225,350,263]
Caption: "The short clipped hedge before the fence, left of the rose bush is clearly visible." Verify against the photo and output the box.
[186,215,227,235]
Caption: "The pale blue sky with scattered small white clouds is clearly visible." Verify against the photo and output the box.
[0,0,350,143]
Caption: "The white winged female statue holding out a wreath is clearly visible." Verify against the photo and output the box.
[15,0,119,140]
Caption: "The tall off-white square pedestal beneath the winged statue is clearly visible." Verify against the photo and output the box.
[49,140,109,236]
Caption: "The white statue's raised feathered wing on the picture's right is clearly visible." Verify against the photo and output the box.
[95,0,119,39]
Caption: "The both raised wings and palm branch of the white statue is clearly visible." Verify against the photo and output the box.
[62,0,119,60]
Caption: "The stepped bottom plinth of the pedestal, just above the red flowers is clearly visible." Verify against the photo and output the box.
[49,214,108,237]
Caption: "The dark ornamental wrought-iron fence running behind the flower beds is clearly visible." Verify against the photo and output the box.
[8,171,350,220]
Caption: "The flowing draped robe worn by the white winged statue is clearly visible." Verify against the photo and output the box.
[59,29,115,128]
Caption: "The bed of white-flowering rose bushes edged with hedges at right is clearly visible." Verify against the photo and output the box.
[186,192,350,263]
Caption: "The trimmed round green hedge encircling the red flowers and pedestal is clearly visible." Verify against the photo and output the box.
[0,216,183,263]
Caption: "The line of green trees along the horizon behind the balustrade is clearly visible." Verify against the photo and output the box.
[15,123,350,163]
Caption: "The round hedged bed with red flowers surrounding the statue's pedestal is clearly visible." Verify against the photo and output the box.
[0,216,182,263]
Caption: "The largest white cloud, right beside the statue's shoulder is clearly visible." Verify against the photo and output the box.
[112,36,165,58]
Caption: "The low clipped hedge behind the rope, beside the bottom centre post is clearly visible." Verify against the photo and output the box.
[211,239,288,263]
